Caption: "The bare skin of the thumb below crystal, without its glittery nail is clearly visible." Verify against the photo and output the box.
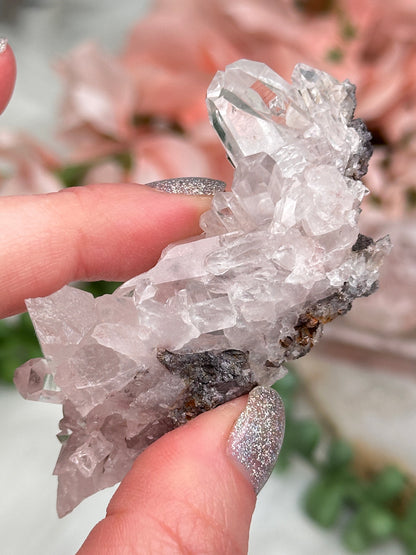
[80,397,256,555]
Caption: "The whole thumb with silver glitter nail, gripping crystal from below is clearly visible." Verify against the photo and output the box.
[78,387,284,555]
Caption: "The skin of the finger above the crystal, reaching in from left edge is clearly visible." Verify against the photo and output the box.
[0,184,211,317]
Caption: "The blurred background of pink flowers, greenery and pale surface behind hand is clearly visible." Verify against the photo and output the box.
[0,0,416,555]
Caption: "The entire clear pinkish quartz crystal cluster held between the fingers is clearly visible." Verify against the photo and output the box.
[15,60,390,516]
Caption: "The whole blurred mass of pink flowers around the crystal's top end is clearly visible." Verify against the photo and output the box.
[52,0,416,213]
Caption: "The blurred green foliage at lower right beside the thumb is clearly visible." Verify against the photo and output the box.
[273,372,416,555]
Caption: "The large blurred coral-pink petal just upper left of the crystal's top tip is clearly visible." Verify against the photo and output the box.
[121,8,242,128]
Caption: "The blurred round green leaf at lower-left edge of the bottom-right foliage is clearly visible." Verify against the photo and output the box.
[305,478,344,528]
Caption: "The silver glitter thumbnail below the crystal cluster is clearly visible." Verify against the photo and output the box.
[228,386,285,494]
